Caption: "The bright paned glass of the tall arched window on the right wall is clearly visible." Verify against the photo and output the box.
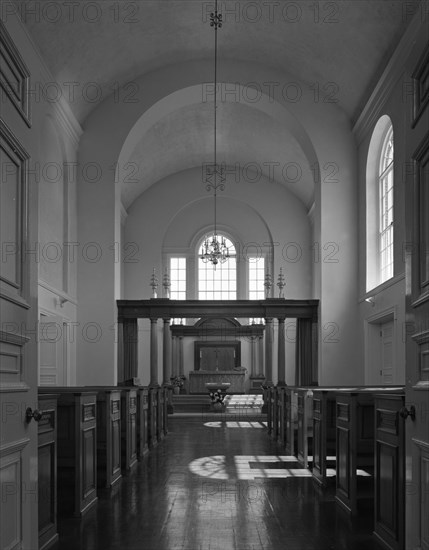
[378,126,393,283]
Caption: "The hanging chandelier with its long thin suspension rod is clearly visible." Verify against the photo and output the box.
[200,0,229,269]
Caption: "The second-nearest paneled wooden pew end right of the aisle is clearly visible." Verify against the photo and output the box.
[335,387,403,515]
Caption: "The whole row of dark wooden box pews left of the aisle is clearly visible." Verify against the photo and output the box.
[38,386,170,550]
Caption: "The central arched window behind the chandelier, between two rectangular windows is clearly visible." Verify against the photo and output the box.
[198,234,237,300]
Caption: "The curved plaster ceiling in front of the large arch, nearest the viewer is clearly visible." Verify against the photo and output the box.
[19,0,419,122]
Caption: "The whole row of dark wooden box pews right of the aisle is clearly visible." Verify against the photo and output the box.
[264,386,407,549]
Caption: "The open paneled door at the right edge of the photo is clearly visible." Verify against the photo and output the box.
[402,33,429,550]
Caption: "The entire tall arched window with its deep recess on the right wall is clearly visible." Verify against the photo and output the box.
[366,115,394,292]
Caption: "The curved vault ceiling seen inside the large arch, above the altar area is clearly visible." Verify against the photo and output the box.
[122,103,313,208]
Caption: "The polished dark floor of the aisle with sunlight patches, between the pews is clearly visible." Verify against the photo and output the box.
[55,414,379,550]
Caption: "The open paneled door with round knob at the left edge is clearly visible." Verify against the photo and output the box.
[0,112,38,549]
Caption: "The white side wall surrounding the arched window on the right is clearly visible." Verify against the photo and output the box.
[354,24,413,384]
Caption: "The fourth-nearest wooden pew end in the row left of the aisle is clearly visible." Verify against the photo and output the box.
[120,387,137,472]
